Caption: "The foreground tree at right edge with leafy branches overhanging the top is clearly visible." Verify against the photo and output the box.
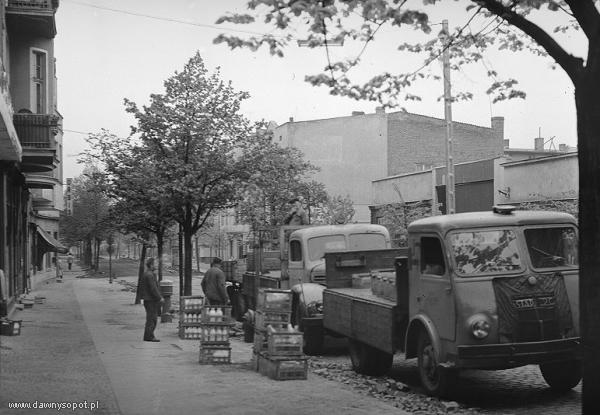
[215,0,600,413]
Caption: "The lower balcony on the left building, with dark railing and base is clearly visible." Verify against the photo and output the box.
[13,114,58,173]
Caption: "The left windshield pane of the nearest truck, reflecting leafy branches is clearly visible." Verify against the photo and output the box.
[450,229,521,275]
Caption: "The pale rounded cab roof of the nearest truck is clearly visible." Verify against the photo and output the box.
[408,210,577,234]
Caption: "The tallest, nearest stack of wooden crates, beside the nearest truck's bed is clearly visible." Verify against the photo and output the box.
[253,288,308,380]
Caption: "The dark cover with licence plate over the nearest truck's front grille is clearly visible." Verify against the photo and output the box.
[493,273,573,343]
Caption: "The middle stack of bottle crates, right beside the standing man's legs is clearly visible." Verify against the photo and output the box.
[199,305,232,365]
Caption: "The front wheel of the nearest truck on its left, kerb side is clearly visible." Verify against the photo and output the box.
[417,330,457,397]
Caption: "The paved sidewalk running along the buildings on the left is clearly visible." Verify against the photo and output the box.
[0,267,403,415]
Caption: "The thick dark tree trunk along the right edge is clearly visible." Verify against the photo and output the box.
[575,43,600,414]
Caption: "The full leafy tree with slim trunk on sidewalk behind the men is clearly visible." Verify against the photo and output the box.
[125,53,257,295]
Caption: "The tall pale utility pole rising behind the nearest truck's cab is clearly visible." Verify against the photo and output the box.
[442,20,456,214]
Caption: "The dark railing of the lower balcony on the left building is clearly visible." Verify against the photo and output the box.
[13,114,58,149]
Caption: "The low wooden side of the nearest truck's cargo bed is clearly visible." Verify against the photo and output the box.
[323,288,406,353]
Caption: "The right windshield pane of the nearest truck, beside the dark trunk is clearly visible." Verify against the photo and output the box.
[525,226,579,268]
